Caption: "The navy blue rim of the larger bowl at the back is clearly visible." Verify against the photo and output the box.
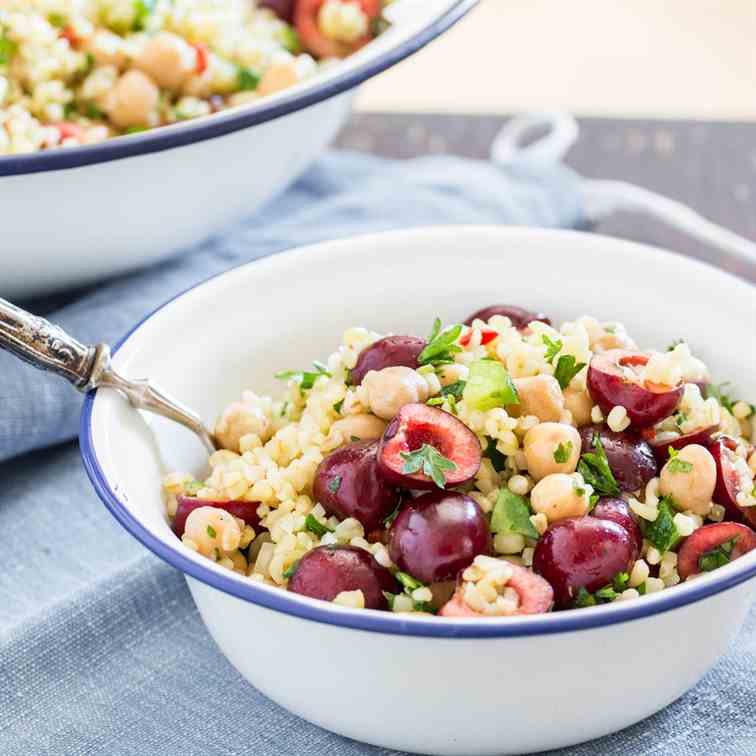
[0,0,479,176]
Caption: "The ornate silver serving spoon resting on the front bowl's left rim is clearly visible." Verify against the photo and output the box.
[0,298,219,452]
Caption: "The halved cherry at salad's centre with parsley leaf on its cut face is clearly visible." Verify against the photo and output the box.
[378,403,482,489]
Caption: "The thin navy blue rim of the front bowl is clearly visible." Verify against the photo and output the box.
[79,229,756,638]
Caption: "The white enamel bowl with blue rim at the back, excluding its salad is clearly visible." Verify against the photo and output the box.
[0,0,477,299]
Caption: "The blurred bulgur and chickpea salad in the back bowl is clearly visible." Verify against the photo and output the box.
[0,0,391,155]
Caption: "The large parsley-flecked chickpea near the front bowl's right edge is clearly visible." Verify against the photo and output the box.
[659,444,717,515]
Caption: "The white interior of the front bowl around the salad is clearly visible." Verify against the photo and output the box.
[82,227,756,626]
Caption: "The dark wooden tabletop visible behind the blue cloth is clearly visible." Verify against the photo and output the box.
[338,113,756,283]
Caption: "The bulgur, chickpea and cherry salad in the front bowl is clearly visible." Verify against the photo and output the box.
[164,305,756,618]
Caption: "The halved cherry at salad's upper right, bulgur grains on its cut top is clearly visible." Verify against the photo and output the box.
[588,349,683,428]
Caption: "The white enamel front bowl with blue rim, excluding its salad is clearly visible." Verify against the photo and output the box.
[81,227,756,756]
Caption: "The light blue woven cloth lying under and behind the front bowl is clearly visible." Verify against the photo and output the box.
[0,153,756,756]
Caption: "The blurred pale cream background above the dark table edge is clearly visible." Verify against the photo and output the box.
[357,0,756,120]
